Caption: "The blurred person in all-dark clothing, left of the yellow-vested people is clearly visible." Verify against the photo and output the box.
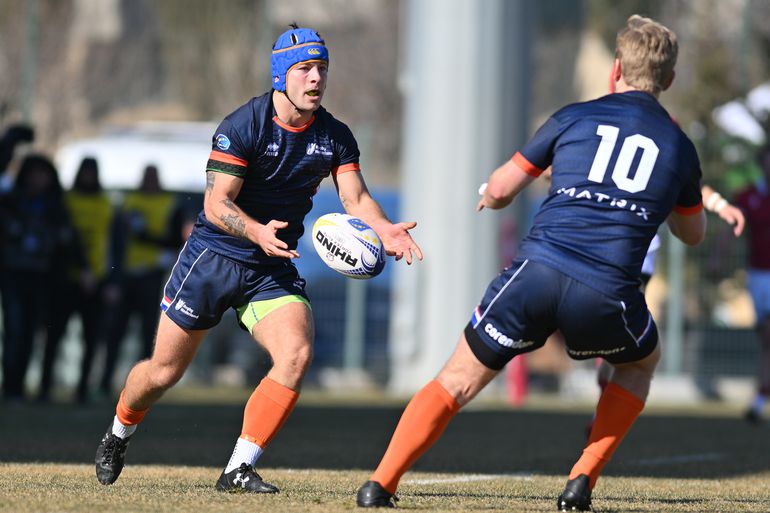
[0,150,75,400]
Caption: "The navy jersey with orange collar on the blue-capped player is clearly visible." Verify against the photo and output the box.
[192,93,360,264]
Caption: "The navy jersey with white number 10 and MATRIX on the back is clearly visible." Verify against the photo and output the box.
[513,91,703,296]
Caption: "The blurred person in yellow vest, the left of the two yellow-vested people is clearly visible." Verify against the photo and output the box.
[39,157,115,402]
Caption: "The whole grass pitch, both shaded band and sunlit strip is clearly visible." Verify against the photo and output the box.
[0,388,770,513]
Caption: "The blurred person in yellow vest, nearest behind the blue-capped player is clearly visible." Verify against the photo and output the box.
[101,165,176,394]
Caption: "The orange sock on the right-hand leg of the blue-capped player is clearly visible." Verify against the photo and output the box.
[241,377,299,449]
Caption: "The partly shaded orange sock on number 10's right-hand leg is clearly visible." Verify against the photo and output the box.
[569,383,644,489]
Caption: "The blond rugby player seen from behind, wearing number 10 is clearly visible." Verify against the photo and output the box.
[357,16,706,511]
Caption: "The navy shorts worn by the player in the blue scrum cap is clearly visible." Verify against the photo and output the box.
[160,238,308,330]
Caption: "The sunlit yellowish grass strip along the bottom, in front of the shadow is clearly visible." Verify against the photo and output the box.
[0,463,770,513]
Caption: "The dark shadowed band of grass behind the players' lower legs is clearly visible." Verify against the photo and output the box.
[0,398,770,478]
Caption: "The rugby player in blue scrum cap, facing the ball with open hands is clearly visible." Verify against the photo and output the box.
[96,25,422,493]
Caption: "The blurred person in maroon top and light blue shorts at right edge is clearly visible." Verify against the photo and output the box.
[735,146,770,422]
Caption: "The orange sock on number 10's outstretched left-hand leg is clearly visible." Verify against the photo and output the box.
[371,380,460,493]
